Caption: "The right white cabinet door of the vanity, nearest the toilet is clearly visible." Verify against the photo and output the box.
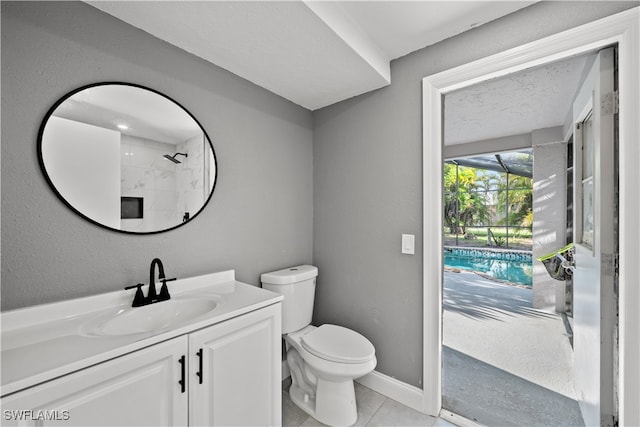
[189,303,282,426]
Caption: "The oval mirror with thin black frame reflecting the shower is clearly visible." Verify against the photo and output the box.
[38,82,217,234]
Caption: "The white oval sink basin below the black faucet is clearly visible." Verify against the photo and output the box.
[87,298,218,335]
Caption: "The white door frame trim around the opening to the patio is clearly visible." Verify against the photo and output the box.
[422,7,640,425]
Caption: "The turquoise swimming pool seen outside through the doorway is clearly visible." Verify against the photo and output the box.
[444,248,533,286]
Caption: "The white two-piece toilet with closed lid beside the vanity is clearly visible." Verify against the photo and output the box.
[260,265,377,426]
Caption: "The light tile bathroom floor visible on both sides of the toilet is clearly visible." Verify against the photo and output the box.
[282,378,453,427]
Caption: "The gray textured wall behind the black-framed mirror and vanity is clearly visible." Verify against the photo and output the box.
[2,1,313,310]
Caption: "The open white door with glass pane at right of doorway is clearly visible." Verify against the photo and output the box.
[573,48,617,426]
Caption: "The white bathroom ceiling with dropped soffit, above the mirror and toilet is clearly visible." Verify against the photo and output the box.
[87,0,535,110]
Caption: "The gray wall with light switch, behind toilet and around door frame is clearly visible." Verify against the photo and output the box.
[313,2,638,387]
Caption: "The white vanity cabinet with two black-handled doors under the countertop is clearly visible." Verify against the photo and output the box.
[1,303,281,426]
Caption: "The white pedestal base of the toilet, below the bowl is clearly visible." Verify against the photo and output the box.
[289,378,358,427]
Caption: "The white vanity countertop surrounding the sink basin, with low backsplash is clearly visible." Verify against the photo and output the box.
[0,270,283,396]
